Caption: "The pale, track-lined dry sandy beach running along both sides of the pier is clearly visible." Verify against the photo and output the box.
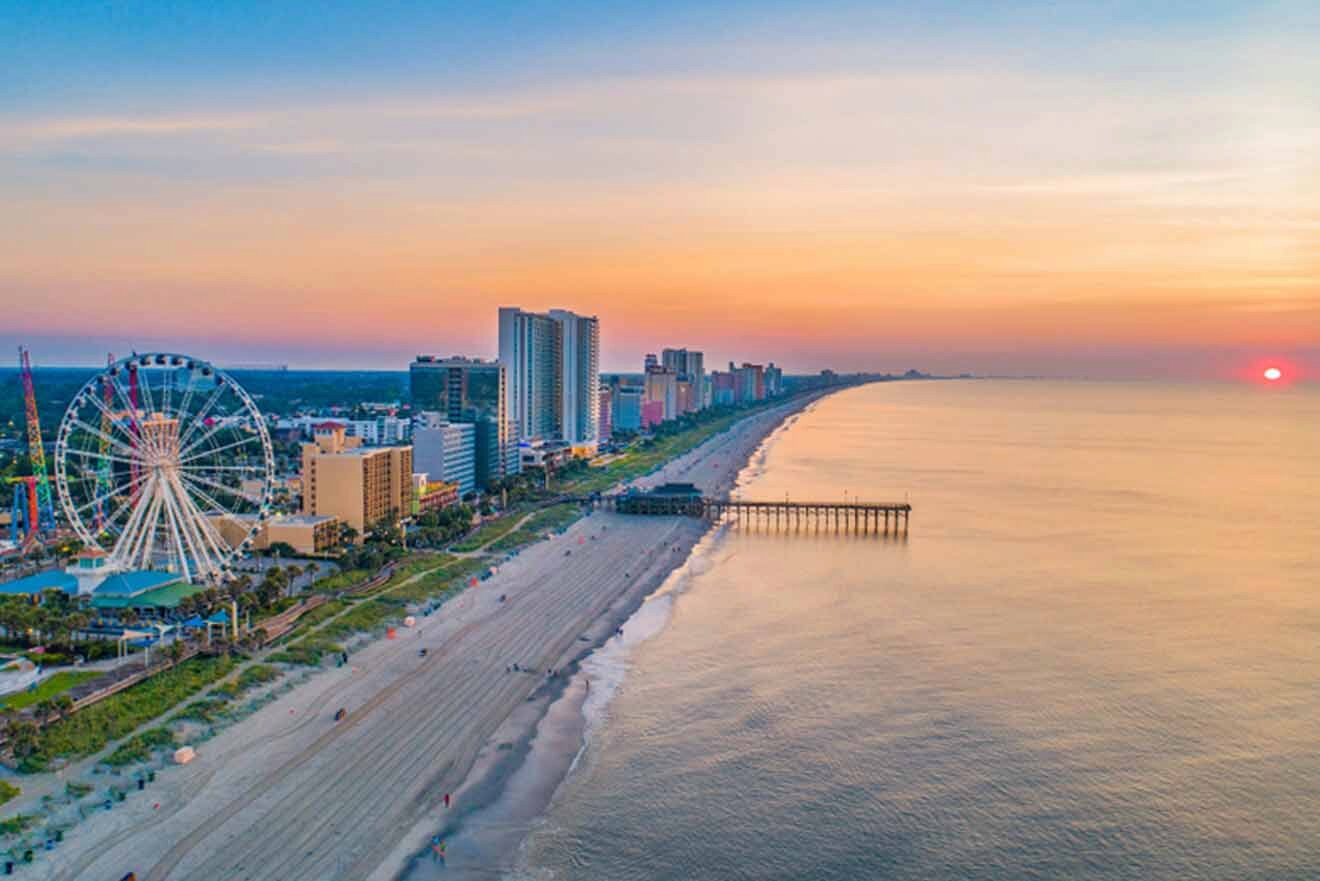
[33,399,809,881]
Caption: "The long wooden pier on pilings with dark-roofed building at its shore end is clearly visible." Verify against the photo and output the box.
[591,491,912,535]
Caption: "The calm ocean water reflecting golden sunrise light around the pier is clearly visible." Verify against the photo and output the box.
[515,382,1320,881]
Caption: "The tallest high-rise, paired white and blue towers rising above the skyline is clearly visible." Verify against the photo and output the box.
[499,306,601,448]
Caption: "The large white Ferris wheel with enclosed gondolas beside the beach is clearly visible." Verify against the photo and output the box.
[55,353,275,584]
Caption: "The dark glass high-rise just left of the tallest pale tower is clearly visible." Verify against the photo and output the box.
[408,355,519,493]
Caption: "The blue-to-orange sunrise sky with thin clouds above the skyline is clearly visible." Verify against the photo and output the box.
[0,0,1320,378]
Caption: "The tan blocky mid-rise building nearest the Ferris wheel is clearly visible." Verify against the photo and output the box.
[302,423,412,534]
